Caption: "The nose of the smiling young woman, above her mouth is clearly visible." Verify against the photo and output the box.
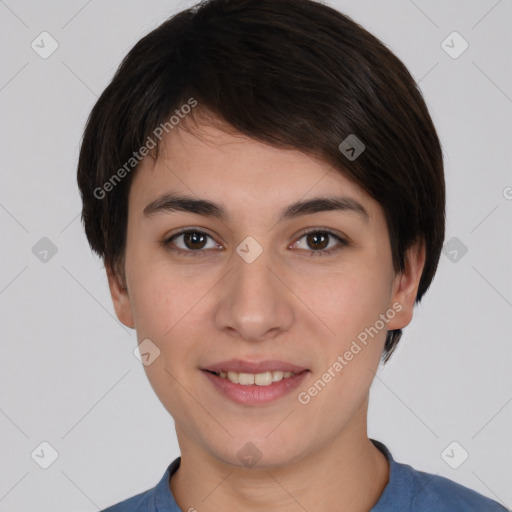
[215,244,296,342]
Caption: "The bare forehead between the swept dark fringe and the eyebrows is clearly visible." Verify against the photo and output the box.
[126,123,377,224]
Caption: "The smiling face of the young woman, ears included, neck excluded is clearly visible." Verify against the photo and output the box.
[107,118,424,467]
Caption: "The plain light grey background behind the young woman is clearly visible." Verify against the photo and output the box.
[0,0,512,512]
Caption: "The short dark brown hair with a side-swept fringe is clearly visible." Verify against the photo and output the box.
[78,0,445,362]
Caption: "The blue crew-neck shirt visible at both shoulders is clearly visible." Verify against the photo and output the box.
[103,439,507,512]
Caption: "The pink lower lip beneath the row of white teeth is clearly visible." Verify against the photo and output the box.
[202,370,309,405]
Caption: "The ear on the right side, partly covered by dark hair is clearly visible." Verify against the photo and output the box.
[388,240,425,330]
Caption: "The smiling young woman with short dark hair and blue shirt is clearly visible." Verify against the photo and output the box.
[78,0,505,512]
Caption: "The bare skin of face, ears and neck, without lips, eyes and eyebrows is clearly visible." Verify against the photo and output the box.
[107,116,425,512]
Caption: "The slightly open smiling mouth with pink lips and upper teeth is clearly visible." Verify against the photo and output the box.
[201,359,310,406]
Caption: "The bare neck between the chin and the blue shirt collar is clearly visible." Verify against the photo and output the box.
[170,403,389,512]
